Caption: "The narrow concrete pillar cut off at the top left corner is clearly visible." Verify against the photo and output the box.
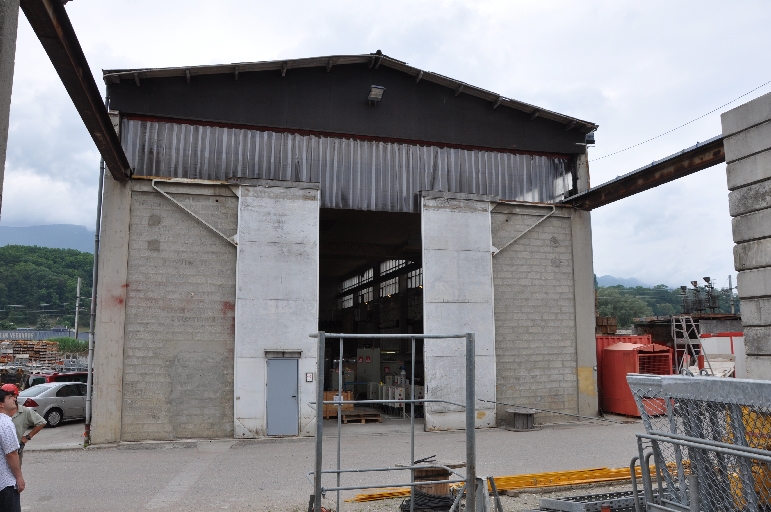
[0,0,19,218]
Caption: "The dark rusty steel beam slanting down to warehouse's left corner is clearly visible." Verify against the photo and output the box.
[20,0,131,181]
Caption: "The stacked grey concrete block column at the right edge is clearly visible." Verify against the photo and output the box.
[722,94,771,379]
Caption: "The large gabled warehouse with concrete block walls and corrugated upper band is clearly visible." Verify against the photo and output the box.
[92,52,597,443]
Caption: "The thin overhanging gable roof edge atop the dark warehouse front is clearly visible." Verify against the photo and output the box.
[102,50,599,133]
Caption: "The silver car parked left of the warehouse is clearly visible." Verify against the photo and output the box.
[17,382,86,427]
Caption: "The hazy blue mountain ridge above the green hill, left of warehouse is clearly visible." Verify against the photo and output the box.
[0,224,94,254]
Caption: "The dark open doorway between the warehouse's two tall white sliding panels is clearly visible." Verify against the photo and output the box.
[319,209,425,416]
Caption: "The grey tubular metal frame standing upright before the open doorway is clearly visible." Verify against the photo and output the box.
[308,331,476,512]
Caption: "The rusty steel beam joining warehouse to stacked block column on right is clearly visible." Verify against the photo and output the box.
[561,135,725,210]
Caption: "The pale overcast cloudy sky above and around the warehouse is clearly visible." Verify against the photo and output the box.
[0,0,771,286]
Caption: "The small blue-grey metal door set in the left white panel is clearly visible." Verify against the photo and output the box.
[267,359,300,436]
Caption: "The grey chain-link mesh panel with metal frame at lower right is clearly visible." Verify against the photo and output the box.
[627,375,771,512]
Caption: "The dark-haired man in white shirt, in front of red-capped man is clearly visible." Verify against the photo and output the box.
[0,389,25,512]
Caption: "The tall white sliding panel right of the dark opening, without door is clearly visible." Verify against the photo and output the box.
[421,197,495,430]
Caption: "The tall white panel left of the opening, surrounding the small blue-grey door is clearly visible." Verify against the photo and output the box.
[234,183,319,437]
